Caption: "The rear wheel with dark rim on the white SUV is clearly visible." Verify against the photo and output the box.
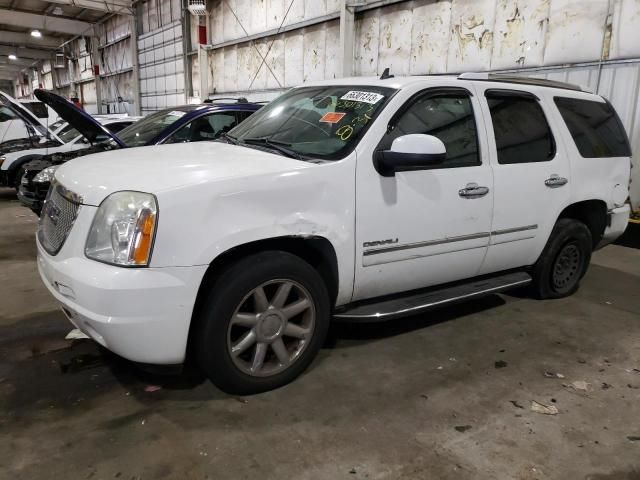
[532,218,593,299]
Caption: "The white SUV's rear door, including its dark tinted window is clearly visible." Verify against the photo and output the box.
[476,83,571,274]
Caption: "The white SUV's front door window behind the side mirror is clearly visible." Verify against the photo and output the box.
[381,92,481,168]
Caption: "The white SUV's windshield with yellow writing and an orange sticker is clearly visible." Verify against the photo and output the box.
[229,85,395,159]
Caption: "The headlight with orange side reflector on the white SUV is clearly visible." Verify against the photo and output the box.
[84,192,158,266]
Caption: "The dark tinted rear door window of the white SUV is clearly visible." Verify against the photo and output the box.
[486,90,556,165]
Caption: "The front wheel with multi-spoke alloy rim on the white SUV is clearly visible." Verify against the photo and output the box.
[194,251,330,395]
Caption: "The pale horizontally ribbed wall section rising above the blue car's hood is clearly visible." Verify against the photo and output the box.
[138,0,186,114]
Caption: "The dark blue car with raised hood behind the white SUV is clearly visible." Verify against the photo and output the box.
[18,90,263,215]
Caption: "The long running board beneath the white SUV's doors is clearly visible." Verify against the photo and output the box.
[333,272,532,322]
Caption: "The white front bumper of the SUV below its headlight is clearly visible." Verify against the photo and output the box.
[36,218,206,365]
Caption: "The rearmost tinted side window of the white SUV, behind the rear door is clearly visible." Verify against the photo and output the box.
[554,97,631,158]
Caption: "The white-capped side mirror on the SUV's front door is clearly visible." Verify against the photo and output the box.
[373,133,447,177]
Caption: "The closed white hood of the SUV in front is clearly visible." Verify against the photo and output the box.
[55,142,313,206]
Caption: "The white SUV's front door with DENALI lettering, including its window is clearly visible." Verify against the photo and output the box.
[354,88,493,300]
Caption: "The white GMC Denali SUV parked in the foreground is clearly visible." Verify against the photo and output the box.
[38,74,631,393]
